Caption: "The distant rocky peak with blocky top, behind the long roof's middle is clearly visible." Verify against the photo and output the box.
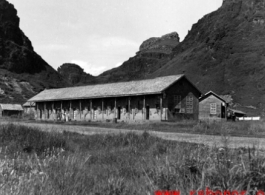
[93,32,179,83]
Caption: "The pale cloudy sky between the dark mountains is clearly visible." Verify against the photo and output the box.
[7,0,222,76]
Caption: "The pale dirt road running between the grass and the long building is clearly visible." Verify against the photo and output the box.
[0,121,265,149]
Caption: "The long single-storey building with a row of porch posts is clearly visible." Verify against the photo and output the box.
[28,75,201,121]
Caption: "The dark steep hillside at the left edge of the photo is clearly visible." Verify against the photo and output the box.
[0,0,65,103]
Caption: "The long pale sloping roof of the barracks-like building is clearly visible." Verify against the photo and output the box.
[28,75,184,102]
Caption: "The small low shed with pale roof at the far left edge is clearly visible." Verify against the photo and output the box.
[0,104,23,117]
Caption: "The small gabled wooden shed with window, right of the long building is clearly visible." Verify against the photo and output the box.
[199,91,227,121]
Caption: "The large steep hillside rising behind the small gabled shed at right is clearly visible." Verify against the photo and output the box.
[148,0,265,116]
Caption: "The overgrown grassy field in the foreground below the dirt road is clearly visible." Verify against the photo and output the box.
[0,124,265,195]
